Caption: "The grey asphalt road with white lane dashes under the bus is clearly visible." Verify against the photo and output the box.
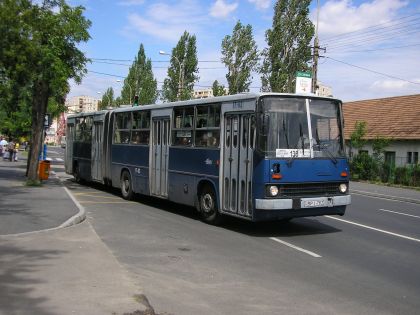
[55,172,420,315]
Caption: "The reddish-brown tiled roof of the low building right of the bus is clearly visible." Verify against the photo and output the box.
[343,94,420,140]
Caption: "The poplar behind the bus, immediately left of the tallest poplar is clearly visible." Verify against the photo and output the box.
[222,21,259,94]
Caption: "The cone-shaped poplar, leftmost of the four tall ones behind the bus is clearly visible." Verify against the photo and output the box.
[121,44,158,105]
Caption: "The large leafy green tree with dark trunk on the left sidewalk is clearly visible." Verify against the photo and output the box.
[0,0,91,183]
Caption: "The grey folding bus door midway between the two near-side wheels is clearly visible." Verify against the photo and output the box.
[150,117,170,198]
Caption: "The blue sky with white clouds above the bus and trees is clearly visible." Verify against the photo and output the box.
[68,0,420,101]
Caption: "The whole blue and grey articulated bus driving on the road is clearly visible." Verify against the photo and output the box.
[66,93,351,223]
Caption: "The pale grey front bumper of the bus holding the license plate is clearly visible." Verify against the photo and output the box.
[255,195,351,210]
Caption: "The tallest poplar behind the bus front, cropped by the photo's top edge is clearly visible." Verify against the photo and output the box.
[260,0,314,93]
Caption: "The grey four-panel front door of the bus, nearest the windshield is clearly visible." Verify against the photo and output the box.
[222,113,255,217]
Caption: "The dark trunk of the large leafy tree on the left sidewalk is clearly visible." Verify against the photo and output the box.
[28,80,49,182]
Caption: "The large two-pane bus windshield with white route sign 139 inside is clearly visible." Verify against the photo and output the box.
[258,97,344,161]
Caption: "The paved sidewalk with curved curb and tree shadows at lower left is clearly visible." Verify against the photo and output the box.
[0,161,154,315]
